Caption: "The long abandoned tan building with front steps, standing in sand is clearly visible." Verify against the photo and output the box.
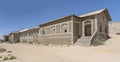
[3,9,111,46]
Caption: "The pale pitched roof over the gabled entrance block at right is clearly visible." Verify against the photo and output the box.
[79,8,111,21]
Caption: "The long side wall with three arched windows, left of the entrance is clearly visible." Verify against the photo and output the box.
[37,17,72,45]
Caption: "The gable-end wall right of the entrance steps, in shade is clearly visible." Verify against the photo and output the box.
[97,12,109,40]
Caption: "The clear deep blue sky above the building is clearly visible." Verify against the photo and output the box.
[0,0,120,38]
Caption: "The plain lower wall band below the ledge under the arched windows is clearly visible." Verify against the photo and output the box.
[37,33,71,45]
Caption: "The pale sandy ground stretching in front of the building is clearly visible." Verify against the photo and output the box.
[0,35,120,62]
